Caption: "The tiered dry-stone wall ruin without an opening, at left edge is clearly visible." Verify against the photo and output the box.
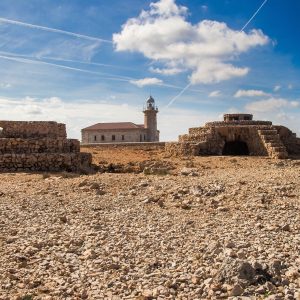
[0,121,92,172]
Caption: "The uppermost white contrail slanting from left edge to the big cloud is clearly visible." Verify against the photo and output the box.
[0,18,112,44]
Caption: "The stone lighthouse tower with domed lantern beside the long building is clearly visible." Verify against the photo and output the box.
[143,96,159,142]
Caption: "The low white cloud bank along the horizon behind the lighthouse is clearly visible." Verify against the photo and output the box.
[0,97,216,141]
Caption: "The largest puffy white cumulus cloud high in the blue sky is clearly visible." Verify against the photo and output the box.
[113,0,269,84]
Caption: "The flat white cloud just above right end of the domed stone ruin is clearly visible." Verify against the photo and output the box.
[246,97,300,112]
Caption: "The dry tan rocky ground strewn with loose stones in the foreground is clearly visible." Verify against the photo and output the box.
[0,153,300,300]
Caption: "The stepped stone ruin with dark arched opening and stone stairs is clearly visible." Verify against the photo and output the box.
[166,114,300,159]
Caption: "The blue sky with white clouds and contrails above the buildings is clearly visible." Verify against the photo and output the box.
[0,0,300,140]
